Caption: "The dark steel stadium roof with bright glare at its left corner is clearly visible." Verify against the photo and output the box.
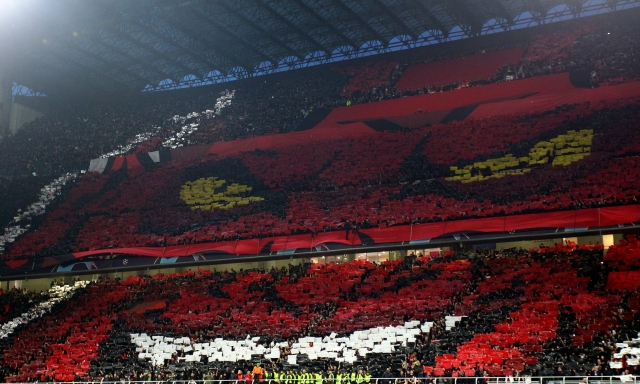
[0,0,640,95]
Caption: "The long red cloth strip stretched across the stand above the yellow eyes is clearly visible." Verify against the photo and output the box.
[104,73,640,170]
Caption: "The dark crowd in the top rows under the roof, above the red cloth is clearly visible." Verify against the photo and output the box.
[0,13,639,175]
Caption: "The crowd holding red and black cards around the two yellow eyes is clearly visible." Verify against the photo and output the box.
[4,95,640,259]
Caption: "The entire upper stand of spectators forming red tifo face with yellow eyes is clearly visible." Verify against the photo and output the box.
[0,13,640,264]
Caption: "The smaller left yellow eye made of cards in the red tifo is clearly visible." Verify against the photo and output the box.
[180,177,264,211]
